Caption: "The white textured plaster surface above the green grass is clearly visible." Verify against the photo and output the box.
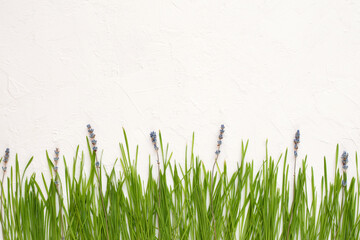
[0,0,360,185]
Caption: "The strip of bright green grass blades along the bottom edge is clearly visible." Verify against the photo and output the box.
[0,130,360,240]
